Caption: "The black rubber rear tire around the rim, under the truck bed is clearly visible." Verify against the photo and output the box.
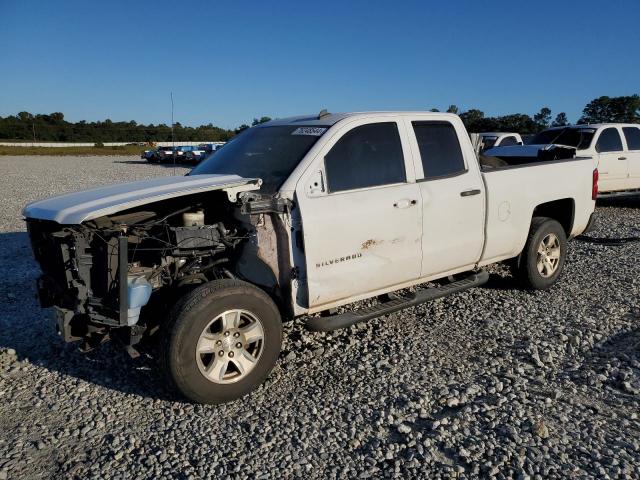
[512,217,567,290]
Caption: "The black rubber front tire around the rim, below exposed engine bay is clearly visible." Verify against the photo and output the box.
[160,280,282,404]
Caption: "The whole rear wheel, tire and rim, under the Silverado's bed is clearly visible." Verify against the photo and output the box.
[514,217,567,290]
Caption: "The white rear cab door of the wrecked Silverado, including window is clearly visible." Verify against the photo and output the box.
[406,117,485,277]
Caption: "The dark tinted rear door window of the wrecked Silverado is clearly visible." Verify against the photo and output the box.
[412,122,466,179]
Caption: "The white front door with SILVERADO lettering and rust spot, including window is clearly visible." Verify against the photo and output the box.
[296,116,422,309]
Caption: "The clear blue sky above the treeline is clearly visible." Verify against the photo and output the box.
[0,0,640,127]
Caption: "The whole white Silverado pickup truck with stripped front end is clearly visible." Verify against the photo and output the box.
[24,112,597,403]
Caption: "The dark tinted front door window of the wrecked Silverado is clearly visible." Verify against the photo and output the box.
[324,122,407,193]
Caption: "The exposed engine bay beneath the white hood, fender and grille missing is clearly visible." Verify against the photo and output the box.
[27,191,291,350]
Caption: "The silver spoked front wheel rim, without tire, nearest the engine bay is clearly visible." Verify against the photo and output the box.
[195,309,264,383]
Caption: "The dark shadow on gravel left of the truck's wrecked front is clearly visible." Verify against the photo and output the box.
[0,232,180,401]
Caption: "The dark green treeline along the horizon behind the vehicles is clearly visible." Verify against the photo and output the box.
[0,95,640,143]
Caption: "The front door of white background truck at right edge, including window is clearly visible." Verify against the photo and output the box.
[595,127,629,192]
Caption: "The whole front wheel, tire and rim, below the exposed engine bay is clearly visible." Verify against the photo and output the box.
[162,280,282,403]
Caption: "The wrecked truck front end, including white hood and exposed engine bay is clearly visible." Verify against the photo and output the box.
[24,175,298,354]
